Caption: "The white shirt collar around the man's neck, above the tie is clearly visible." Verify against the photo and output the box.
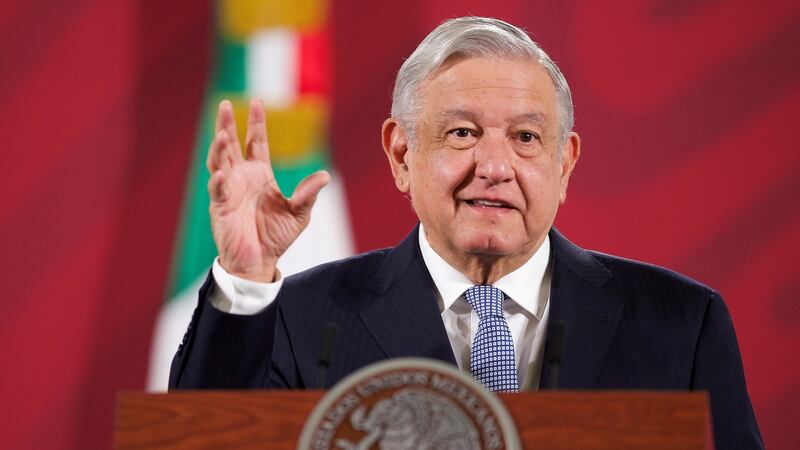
[419,223,550,319]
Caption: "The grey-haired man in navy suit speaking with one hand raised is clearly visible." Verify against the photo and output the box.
[170,17,762,448]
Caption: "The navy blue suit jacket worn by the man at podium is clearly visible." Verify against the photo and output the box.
[170,227,763,449]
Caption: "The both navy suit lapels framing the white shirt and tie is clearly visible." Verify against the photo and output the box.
[360,227,624,380]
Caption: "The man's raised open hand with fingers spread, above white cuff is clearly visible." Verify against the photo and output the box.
[207,99,330,282]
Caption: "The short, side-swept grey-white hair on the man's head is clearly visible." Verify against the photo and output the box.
[392,16,575,148]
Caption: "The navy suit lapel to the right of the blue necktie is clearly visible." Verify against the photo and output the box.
[540,229,624,389]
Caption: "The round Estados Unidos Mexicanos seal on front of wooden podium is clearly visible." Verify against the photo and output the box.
[298,358,521,450]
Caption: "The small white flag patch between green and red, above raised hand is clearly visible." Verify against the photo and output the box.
[245,28,299,108]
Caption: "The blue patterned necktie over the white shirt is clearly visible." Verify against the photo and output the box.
[464,286,519,392]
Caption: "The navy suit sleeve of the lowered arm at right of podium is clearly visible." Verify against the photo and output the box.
[692,292,764,449]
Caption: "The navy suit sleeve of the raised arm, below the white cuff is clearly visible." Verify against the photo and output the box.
[169,273,281,389]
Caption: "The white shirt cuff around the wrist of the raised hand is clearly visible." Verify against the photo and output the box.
[209,257,283,316]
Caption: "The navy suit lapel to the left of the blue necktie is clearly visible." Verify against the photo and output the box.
[360,227,456,365]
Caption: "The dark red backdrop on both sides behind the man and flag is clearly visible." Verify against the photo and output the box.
[0,0,800,449]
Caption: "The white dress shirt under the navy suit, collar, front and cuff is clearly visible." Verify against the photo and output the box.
[209,224,551,389]
